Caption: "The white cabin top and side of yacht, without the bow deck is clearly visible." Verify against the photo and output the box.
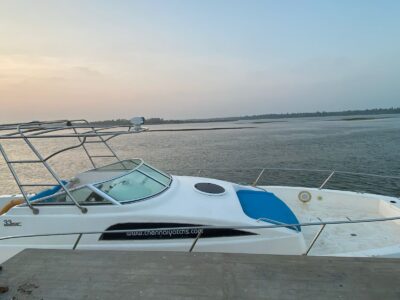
[0,177,306,260]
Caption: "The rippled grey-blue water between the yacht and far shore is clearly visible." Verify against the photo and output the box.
[0,115,400,196]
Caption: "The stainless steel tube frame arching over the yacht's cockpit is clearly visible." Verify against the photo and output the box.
[0,119,146,214]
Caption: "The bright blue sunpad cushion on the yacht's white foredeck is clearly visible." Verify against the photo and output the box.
[236,190,301,231]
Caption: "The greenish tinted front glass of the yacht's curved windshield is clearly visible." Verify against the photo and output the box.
[95,160,172,203]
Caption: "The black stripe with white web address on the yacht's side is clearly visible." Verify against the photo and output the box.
[99,223,256,241]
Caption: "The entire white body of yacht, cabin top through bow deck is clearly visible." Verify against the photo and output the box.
[0,177,400,261]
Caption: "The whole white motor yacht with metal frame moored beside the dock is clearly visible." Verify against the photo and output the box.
[0,118,400,261]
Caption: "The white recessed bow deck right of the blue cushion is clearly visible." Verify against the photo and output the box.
[262,186,400,257]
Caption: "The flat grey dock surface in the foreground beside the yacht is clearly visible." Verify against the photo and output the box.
[0,249,400,299]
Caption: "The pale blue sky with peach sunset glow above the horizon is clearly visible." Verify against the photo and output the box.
[0,0,400,123]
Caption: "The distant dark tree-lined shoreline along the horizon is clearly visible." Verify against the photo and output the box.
[93,107,400,125]
